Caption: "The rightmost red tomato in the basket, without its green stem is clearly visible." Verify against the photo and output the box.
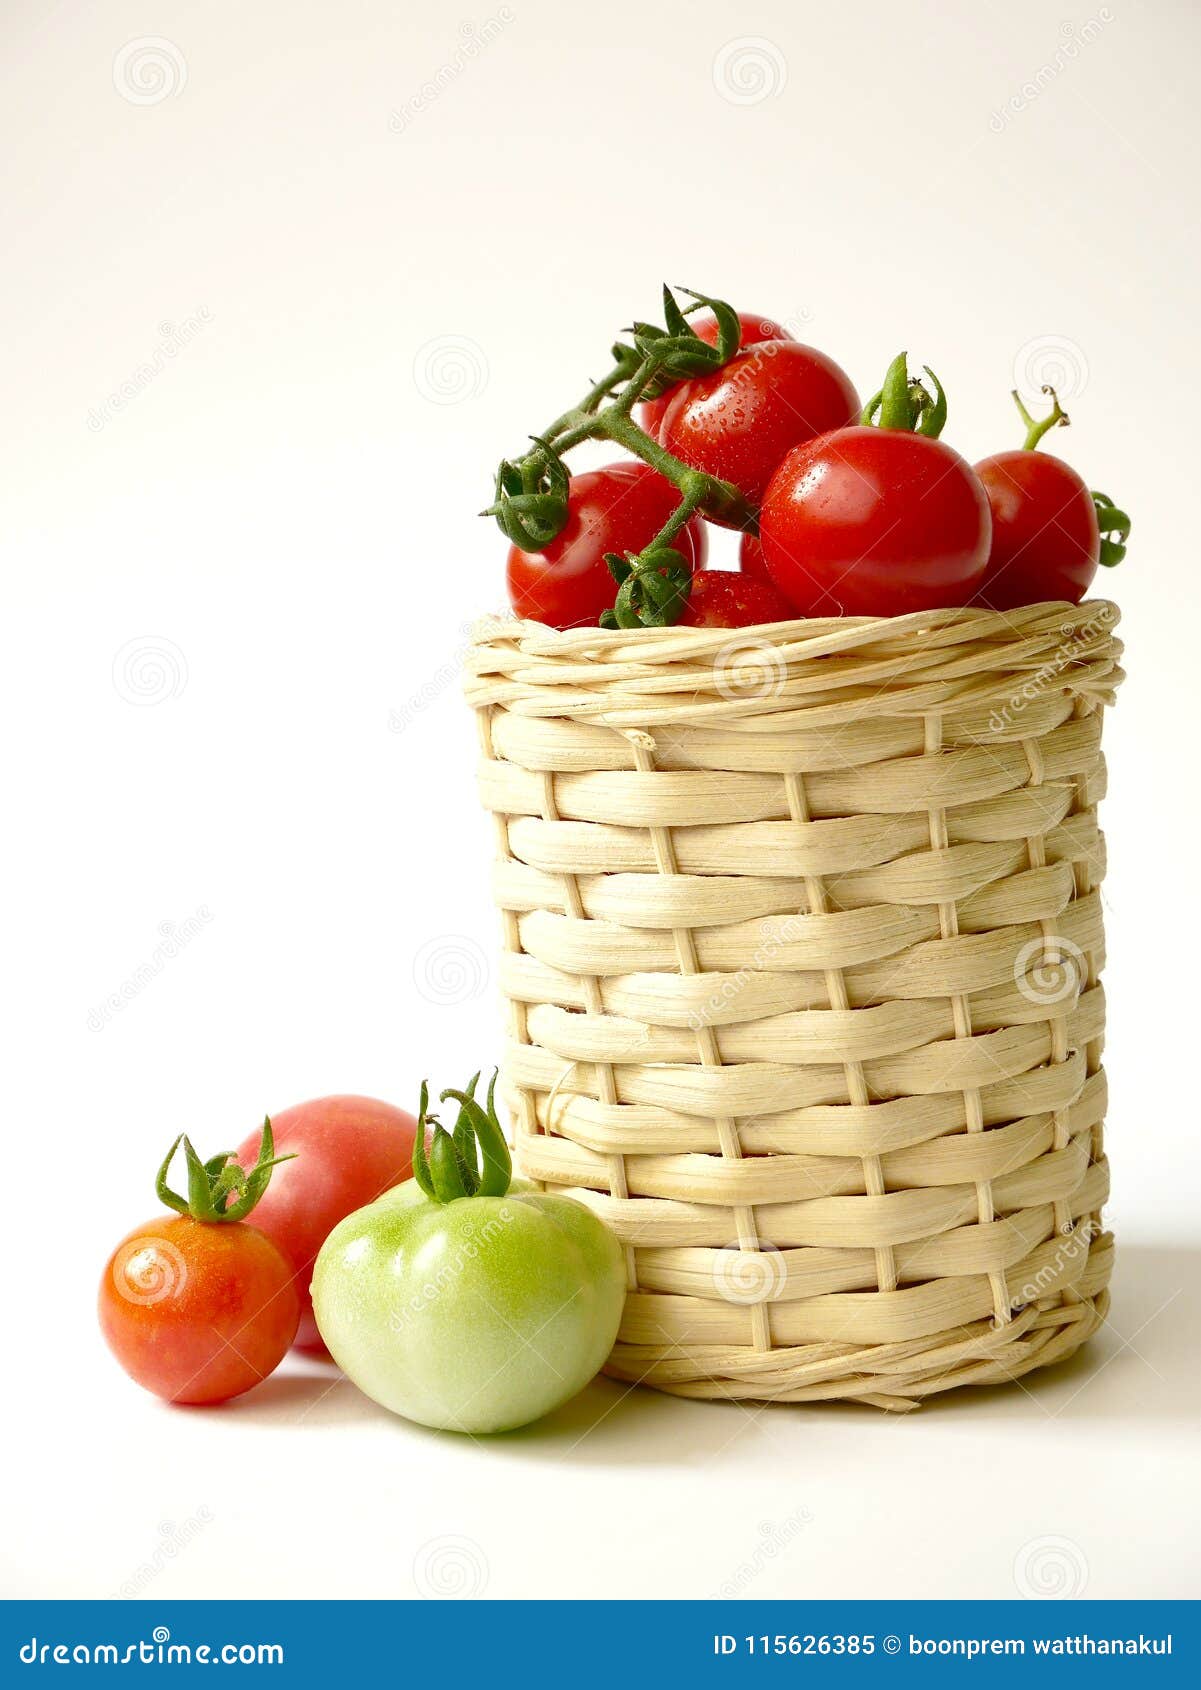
[976,450,1101,610]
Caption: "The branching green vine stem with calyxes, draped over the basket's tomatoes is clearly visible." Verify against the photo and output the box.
[480,287,757,627]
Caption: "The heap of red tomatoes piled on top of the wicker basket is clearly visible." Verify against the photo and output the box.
[508,313,1128,629]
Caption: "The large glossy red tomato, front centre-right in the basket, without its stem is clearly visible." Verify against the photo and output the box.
[758,428,992,617]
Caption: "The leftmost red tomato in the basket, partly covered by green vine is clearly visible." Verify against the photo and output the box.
[508,460,708,629]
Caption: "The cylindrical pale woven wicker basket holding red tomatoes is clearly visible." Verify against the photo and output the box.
[466,600,1122,1409]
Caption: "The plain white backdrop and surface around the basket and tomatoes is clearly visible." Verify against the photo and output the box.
[0,0,1201,1599]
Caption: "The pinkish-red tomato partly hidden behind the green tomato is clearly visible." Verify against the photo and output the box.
[235,1097,417,1350]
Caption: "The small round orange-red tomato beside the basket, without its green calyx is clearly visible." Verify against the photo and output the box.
[100,1215,301,1403]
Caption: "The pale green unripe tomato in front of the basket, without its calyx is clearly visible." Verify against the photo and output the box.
[312,1180,625,1433]
